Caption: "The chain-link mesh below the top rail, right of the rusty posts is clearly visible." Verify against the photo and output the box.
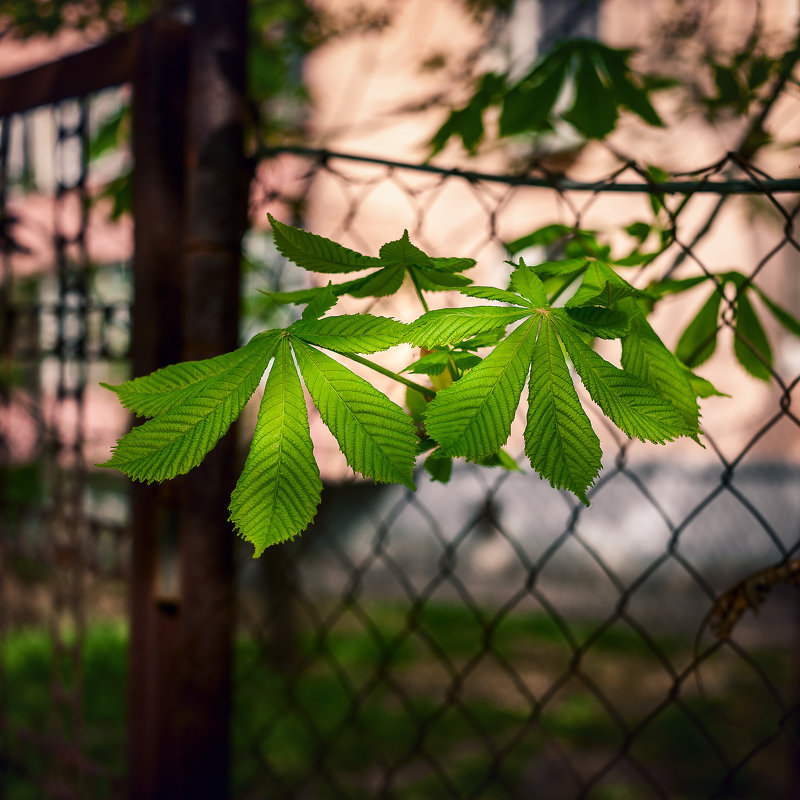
[234,145,800,798]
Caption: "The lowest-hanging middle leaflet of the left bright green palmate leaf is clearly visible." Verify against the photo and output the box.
[230,337,322,556]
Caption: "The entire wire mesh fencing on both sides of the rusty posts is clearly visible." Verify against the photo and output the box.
[0,7,800,800]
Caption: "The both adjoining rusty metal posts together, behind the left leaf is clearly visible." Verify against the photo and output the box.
[128,0,248,800]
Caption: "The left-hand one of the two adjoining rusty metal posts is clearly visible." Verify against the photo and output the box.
[128,12,189,800]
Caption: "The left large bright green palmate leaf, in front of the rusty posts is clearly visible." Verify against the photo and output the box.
[102,316,416,555]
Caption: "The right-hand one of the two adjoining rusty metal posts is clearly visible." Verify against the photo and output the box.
[180,0,249,800]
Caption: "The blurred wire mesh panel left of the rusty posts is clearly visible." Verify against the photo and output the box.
[0,92,130,798]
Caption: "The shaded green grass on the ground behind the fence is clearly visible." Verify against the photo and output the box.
[3,603,791,800]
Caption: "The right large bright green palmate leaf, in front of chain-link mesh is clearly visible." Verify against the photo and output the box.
[422,264,698,496]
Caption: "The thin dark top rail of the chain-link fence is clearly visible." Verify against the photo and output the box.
[258,145,800,195]
